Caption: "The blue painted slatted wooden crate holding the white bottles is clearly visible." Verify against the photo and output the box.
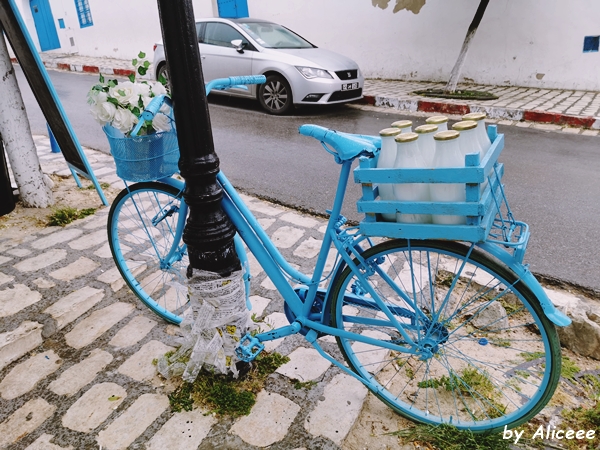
[354,125,512,242]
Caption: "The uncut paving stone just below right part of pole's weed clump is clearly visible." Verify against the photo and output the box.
[229,391,300,447]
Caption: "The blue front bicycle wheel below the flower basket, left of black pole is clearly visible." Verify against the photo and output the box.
[108,182,189,324]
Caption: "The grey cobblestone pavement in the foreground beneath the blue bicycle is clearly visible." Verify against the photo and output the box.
[0,136,366,450]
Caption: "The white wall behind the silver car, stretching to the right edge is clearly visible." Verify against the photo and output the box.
[248,0,600,90]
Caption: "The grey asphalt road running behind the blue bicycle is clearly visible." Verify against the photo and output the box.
[16,67,600,291]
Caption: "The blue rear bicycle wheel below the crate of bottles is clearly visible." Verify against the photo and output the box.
[331,240,561,432]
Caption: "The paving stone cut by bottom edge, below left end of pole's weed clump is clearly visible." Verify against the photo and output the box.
[146,408,217,450]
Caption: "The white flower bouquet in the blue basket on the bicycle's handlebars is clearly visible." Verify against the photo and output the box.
[87,52,179,182]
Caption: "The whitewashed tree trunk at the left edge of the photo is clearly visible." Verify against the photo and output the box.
[0,33,54,208]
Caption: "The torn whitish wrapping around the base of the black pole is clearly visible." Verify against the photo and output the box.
[157,269,249,382]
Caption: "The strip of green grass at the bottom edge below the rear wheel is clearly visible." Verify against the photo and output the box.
[389,425,510,450]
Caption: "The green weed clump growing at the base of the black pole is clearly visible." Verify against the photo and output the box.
[164,352,290,417]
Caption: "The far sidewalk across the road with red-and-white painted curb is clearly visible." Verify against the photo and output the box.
[24,53,600,136]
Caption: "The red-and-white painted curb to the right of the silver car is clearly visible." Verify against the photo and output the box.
[363,95,600,130]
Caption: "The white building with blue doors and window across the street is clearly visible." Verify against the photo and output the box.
[10,0,600,90]
